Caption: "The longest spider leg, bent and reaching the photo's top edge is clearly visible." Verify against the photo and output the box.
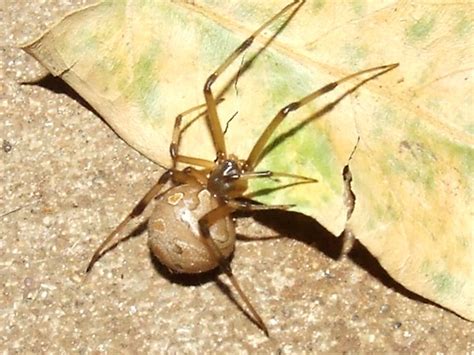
[204,0,300,160]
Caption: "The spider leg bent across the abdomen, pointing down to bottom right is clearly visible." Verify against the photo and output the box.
[199,205,269,336]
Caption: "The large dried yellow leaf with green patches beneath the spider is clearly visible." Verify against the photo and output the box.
[25,0,474,320]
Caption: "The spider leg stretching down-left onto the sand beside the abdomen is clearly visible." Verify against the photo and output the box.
[86,170,173,272]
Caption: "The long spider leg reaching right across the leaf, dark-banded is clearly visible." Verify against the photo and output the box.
[244,63,399,171]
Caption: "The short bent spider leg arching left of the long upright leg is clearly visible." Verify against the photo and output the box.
[170,98,224,168]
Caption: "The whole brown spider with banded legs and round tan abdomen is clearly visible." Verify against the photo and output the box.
[87,0,398,336]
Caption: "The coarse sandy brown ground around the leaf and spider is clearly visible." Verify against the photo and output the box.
[0,0,474,354]
